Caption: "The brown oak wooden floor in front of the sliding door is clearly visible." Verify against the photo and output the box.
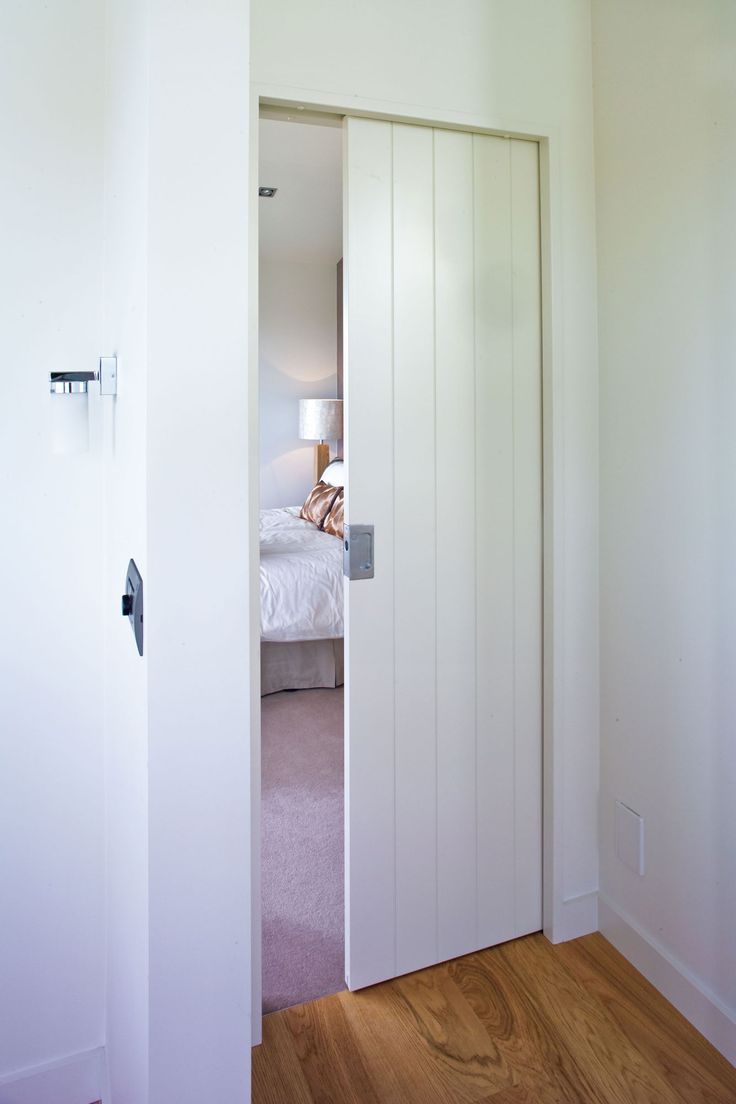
[253,935,736,1104]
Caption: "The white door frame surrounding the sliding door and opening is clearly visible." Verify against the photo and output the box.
[248,84,597,1045]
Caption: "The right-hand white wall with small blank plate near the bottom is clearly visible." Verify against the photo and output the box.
[594,0,736,1061]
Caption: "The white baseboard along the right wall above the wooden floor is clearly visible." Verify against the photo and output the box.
[598,893,736,1065]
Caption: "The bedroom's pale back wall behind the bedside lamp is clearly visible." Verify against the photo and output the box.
[258,261,338,509]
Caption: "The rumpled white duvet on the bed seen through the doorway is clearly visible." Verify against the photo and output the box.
[260,506,344,641]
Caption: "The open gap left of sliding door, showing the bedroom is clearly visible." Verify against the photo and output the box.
[258,116,344,1012]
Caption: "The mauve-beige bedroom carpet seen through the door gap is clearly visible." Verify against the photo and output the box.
[262,688,345,1012]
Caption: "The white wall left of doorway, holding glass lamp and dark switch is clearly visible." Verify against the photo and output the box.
[0,0,250,1104]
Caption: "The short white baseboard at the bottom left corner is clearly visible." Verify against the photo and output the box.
[0,1047,105,1104]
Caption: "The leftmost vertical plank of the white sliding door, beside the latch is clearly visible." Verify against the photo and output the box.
[344,119,396,988]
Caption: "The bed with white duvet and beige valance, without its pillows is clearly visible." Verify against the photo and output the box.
[260,506,343,694]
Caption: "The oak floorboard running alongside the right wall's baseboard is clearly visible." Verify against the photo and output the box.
[558,933,736,1104]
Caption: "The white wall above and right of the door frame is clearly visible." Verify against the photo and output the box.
[252,0,598,935]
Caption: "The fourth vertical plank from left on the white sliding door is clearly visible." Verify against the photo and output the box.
[473,135,515,946]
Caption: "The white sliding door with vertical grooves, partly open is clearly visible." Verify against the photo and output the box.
[344,118,542,989]
